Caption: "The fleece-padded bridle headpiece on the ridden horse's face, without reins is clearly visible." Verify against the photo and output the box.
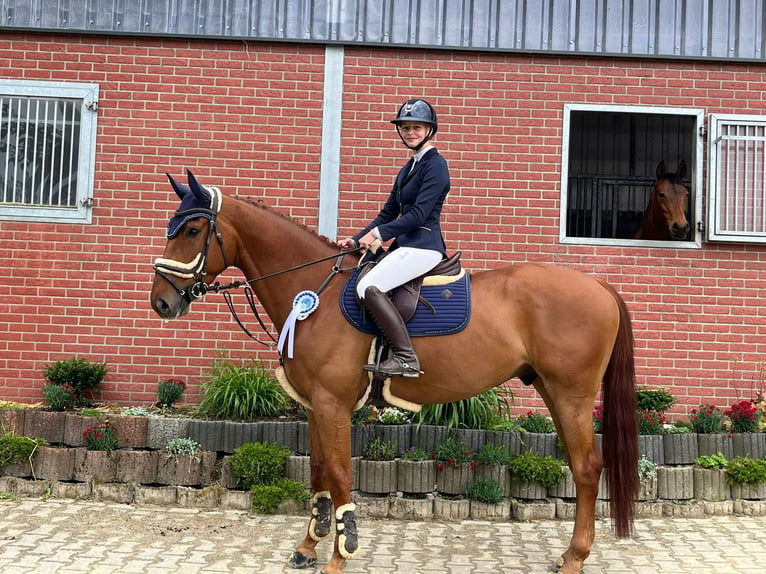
[154,208,229,304]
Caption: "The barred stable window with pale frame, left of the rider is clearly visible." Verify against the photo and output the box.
[0,80,98,223]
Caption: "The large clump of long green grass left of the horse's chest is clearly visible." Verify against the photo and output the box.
[197,359,293,420]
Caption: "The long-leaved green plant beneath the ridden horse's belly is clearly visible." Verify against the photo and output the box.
[412,387,513,429]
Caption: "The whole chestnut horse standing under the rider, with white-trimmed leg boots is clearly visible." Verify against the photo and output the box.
[151,172,638,574]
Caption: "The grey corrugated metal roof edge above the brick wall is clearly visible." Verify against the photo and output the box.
[0,0,765,61]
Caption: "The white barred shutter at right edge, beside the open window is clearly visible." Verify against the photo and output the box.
[706,114,766,243]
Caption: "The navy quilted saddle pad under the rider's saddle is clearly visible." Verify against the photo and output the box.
[340,270,471,337]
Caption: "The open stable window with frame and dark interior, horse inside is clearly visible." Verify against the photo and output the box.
[559,104,704,248]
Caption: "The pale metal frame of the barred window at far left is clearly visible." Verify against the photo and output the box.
[0,79,98,224]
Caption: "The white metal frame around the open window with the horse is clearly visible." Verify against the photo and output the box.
[559,104,705,249]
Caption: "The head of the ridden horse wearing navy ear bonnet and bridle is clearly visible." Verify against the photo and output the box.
[150,171,232,319]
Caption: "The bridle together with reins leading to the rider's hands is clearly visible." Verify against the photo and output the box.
[154,208,363,346]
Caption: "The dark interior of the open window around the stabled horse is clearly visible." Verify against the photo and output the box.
[564,109,697,241]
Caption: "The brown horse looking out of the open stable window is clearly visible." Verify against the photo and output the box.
[633,160,690,241]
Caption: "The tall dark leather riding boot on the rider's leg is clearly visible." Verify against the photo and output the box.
[362,287,421,377]
